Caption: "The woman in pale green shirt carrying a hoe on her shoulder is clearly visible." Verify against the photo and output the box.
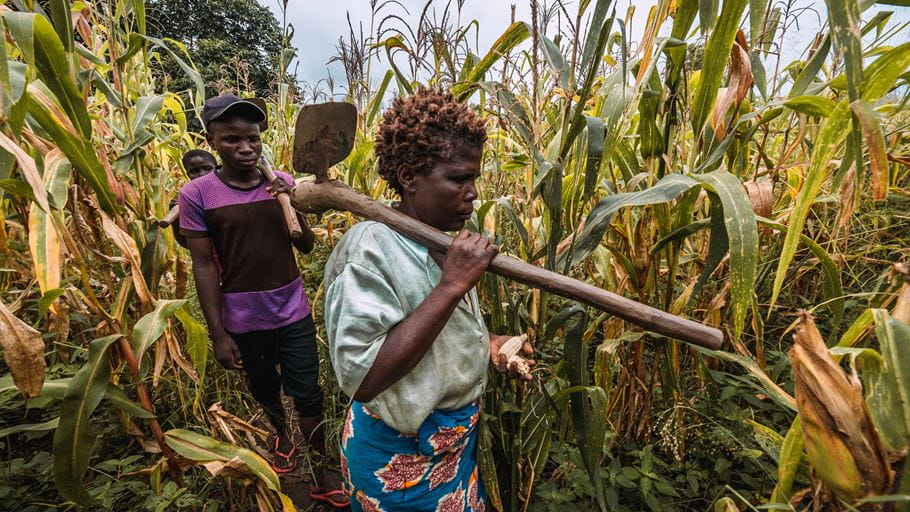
[325,89,533,512]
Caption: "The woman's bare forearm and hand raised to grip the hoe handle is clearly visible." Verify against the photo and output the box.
[354,231,499,403]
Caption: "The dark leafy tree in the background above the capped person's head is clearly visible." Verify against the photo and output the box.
[148,0,292,96]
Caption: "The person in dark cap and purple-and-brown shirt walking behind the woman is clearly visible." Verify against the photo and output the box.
[180,94,348,507]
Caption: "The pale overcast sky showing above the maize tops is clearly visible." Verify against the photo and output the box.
[258,0,910,94]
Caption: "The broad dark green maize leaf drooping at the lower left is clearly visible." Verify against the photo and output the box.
[54,334,121,506]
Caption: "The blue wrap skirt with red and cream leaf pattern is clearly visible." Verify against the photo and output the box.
[341,401,485,512]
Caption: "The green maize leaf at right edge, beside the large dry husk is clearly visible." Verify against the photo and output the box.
[862,309,910,453]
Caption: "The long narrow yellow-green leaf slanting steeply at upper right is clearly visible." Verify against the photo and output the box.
[771,100,851,306]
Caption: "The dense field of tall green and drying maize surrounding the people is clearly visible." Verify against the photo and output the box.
[0,0,910,512]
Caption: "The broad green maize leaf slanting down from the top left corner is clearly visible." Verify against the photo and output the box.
[4,12,92,140]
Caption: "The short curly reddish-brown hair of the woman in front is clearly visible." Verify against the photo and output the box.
[376,87,487,194]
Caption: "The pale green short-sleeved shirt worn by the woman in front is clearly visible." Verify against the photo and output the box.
[325,221,490,433]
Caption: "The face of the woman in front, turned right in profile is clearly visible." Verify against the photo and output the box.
[398,148,483,231]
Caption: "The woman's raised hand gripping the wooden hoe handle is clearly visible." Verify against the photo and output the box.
[440,231,499,296]
